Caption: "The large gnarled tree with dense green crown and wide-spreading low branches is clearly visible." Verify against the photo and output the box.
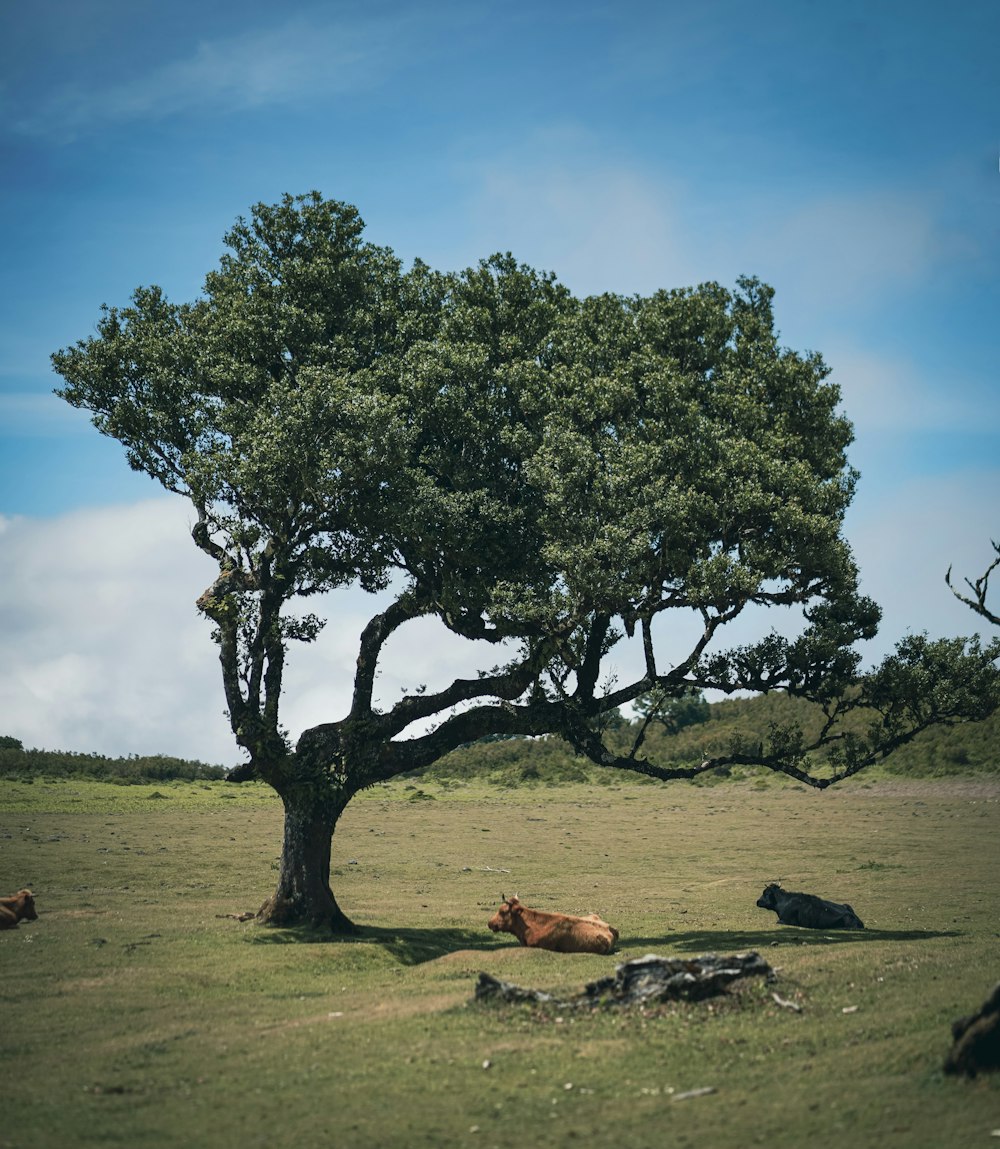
[53,193,1000,931]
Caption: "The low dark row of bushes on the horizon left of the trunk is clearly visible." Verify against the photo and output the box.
[0,735,226,785]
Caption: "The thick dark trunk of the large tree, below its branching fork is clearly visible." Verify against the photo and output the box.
[257,784,357,934]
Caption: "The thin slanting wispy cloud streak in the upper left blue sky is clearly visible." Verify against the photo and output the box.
[16,16,408,138]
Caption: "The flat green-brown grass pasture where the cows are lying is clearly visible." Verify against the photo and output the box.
[0,778,1000,1149]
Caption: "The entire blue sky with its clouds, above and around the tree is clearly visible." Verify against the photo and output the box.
[0,0,1000,761]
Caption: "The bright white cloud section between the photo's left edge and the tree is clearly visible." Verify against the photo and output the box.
[0,499,227,762]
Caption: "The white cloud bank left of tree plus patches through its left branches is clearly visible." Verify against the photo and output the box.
[0,499,517,764]
